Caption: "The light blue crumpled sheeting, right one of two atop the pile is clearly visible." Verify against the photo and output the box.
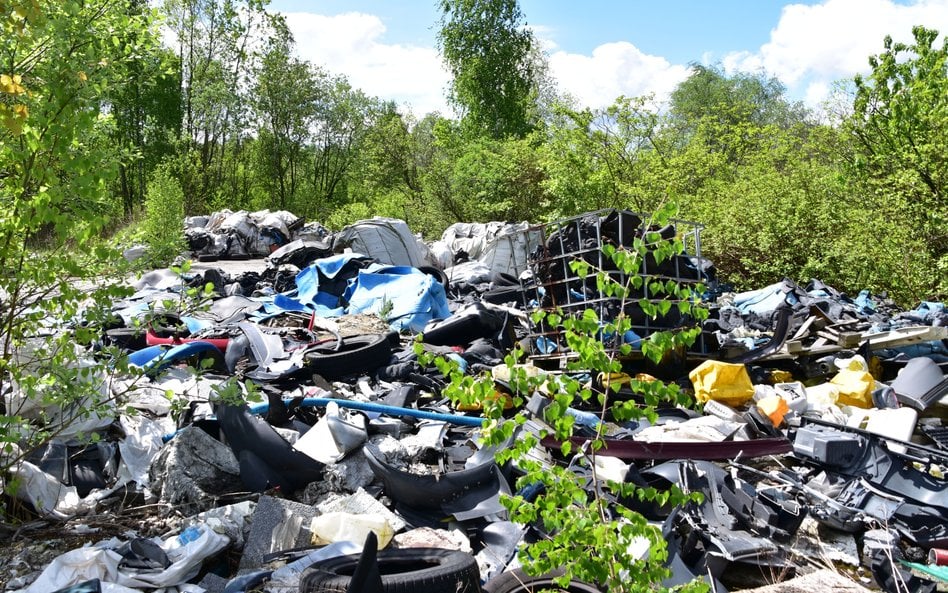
[344,267,451,332]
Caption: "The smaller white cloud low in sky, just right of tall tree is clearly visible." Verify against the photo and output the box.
[550,41,689,107]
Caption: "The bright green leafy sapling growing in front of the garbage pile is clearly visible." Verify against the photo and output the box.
[417,206,707,592]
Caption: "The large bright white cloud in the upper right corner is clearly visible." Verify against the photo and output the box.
[722,0,948,106]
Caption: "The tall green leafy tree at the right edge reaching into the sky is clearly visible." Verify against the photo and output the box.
[849,26,948,299]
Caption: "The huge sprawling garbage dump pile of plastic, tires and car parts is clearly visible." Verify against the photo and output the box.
[5,211,948,593]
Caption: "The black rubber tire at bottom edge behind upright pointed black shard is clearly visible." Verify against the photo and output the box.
[300,548,481,593]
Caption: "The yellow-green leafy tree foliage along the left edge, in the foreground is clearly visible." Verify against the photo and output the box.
[0,0,155,508]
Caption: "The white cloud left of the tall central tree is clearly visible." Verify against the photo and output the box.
[284,12,450,116]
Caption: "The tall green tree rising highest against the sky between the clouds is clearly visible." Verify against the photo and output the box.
[438,0,539,139]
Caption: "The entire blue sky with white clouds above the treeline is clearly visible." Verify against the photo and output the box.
[270,0,948,116]
